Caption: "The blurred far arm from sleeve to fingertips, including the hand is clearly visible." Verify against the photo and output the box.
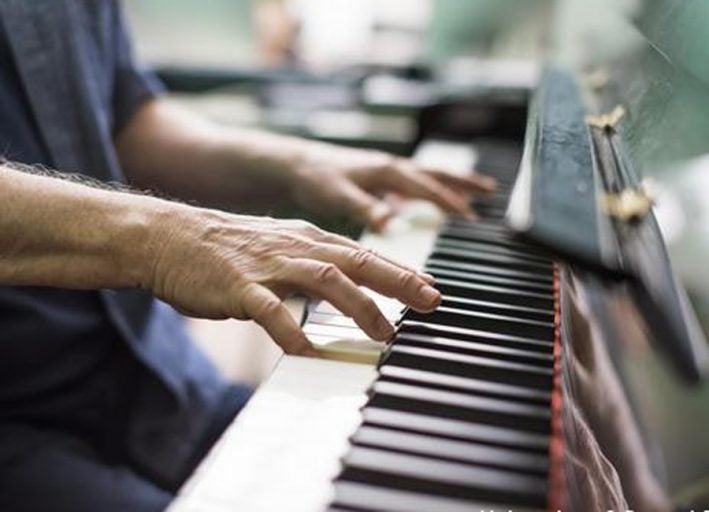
[116,98,494,229]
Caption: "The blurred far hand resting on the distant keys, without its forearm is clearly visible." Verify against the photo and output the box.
[292,144,496,231]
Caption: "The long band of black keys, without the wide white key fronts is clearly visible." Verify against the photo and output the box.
[328,140,558,512]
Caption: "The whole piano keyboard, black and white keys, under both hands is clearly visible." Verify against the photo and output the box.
[169,141,560,512]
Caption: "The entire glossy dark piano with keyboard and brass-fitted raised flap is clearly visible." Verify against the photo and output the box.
[163,2,709,512]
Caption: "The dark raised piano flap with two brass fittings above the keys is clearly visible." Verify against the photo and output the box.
[506,68,709,382]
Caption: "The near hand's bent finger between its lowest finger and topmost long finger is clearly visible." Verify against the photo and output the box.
[286,259,394,341]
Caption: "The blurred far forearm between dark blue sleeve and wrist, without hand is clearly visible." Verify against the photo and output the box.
[116,99,317,208]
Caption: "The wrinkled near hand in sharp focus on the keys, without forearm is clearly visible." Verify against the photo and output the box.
[144,207,440,355]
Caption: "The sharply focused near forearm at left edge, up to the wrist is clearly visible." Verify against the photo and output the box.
[0,165,173,289]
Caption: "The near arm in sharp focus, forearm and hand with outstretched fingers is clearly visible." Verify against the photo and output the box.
[0,165,440,353]
